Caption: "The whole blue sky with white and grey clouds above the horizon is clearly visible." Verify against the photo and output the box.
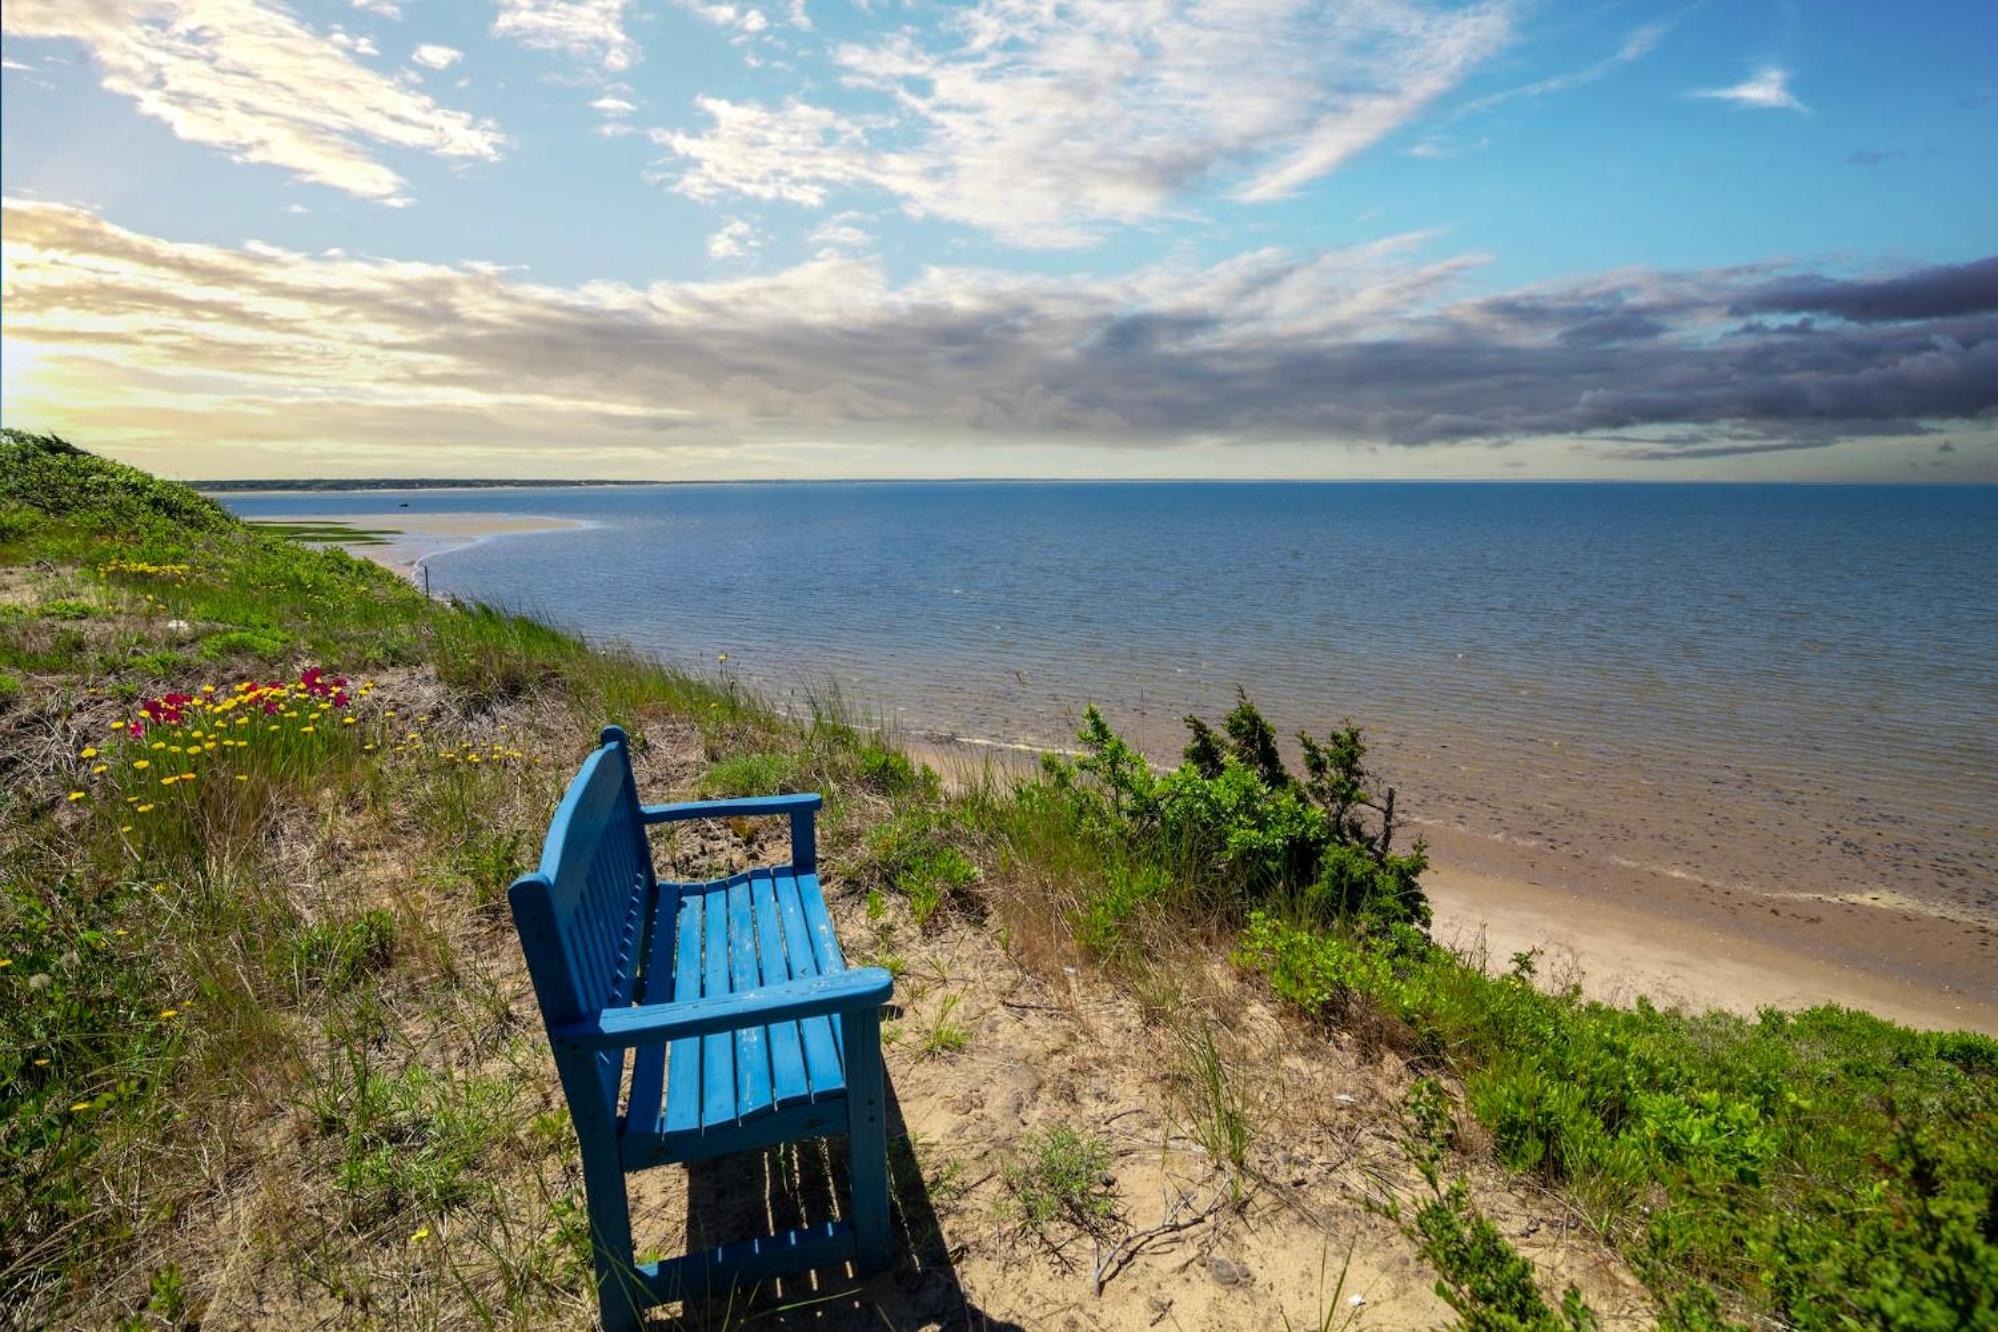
[0,0,1998,483]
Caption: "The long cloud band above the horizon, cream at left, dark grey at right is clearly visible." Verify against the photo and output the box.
[4,202,1998,471]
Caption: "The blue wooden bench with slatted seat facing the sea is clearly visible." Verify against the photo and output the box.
[507,727,893,1332]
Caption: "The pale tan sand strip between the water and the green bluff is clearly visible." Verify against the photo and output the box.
[903,737,1998,1036]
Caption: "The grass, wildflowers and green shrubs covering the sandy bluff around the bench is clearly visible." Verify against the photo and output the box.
[0,431,1998,1330]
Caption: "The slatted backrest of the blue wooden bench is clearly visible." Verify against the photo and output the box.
[507,727,655,1116]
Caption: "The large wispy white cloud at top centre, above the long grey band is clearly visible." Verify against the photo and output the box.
[655,0,1510,246]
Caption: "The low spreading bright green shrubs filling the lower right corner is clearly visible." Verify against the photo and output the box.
[1237,913,1998,1330]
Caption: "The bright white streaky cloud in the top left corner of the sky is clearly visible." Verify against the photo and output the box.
[0,0,505,202]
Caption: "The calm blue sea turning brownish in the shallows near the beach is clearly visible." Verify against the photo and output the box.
[228,483,1998,917]
